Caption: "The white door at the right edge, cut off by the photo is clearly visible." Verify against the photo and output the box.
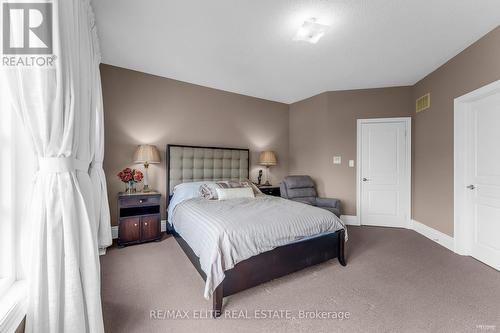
[466,92,500,270]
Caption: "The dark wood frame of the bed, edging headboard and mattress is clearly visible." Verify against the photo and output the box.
[166,145,346,318]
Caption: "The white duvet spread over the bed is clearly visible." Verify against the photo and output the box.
[169,195,345,299]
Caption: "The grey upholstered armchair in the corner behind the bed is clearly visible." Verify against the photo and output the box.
[280,176,340,217]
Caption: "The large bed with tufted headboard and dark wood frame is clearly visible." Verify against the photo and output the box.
[166,145,346,318]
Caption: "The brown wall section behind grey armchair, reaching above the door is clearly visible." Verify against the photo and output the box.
[289,87,413,215]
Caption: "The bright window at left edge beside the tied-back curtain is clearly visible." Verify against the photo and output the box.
[0,69,35,332]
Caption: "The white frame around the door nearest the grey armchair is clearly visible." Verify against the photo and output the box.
[356,117,412,228]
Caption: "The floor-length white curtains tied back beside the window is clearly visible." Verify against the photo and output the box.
[6,0,111,333]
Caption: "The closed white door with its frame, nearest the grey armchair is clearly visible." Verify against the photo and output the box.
[358,118,411,228]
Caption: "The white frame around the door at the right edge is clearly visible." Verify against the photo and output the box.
[453,80,500,255]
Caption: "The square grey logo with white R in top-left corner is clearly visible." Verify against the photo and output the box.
[2,2,52,55]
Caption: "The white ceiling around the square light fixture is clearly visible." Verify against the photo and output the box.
[93,0,500,103]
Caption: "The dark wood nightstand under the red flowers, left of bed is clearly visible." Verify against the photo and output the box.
[118,192,161,246]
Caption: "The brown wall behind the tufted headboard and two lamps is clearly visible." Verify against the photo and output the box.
[101,65,288,225]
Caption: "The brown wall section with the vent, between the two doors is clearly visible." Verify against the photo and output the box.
[413,27,500,236]
